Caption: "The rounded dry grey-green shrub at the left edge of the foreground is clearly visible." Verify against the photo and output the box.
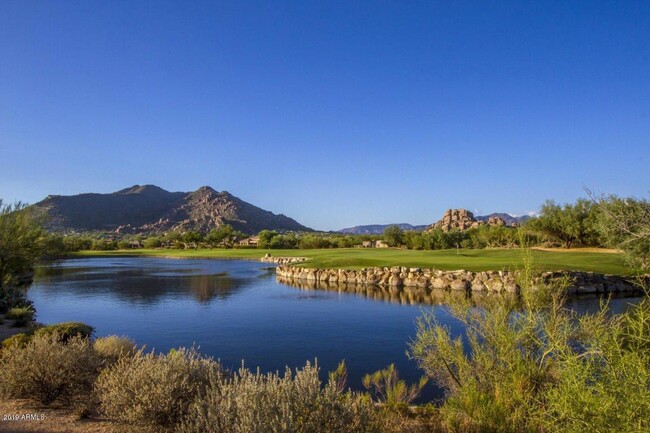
[0,334,99,405]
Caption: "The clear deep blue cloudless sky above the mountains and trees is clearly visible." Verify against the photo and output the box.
[0,0,650,229]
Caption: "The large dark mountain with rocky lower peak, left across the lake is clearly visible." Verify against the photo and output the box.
[34,185,311,234]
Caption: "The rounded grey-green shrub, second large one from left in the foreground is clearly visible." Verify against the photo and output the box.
[95,349,221,431]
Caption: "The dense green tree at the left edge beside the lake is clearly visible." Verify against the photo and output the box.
[0,200,46,297]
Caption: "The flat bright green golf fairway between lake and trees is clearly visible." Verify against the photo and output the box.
[74,248,633,275]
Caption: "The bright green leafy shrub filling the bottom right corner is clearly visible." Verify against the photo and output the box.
[538,298,650,433]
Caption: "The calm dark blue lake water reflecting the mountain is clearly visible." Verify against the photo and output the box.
[28,258,634,399]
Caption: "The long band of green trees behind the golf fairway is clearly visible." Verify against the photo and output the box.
[5,195,650,271]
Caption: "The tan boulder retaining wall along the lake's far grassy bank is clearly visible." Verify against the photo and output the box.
[276,262,650,294]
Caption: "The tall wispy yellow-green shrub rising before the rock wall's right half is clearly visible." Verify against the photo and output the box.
[411,280,576,433]
